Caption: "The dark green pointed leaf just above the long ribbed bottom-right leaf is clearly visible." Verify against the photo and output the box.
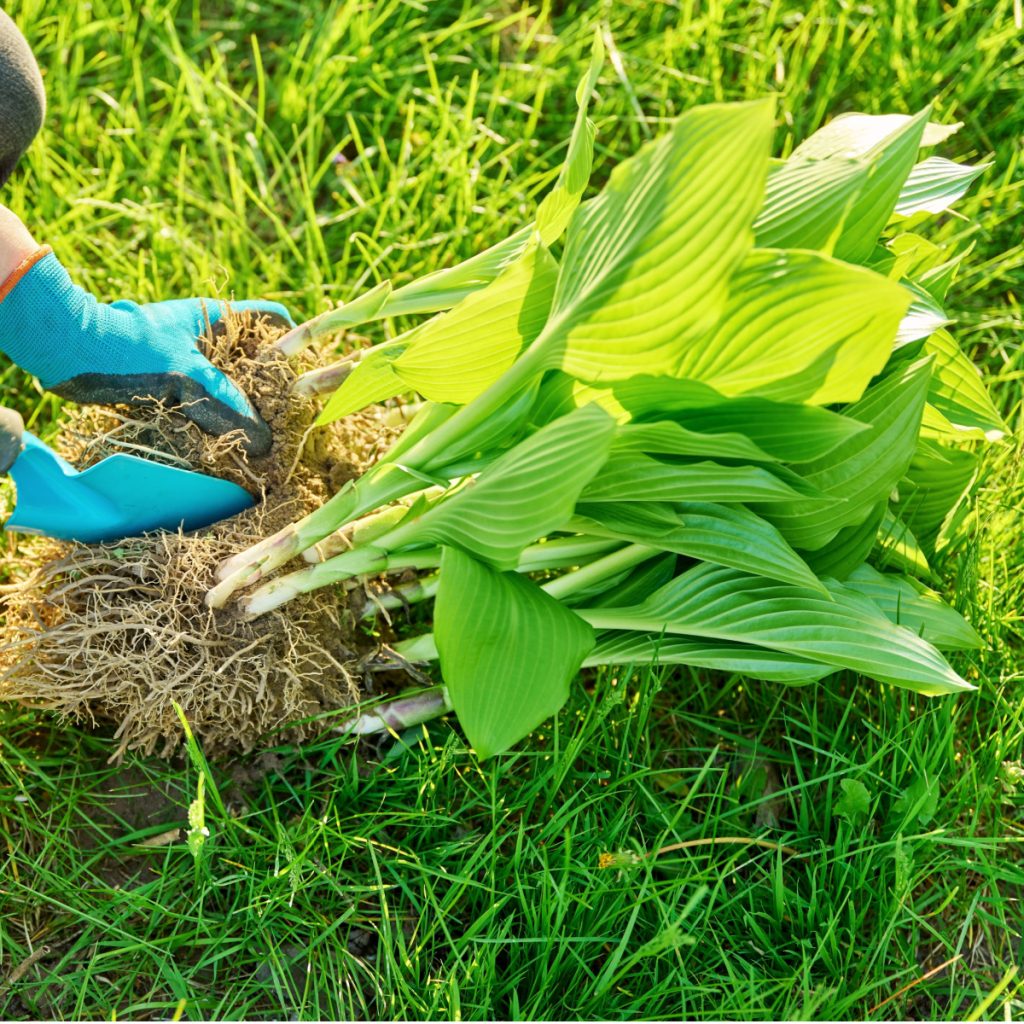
[571,502,824,591]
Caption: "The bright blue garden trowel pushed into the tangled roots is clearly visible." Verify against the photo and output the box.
[0,410,255,544]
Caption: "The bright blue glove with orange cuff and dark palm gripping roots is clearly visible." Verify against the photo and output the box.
[0,246,294,456]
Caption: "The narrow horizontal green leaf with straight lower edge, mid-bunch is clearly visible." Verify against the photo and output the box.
[581,454,828,505]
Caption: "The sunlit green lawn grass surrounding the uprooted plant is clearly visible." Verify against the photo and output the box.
[0,0,1024,1019]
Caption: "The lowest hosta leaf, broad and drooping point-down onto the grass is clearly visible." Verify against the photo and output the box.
[434,548,594,758]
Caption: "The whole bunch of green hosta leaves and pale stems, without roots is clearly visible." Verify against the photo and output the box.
[209,44,1002,756]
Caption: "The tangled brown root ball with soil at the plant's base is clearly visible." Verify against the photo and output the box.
[0,316,405,757]
